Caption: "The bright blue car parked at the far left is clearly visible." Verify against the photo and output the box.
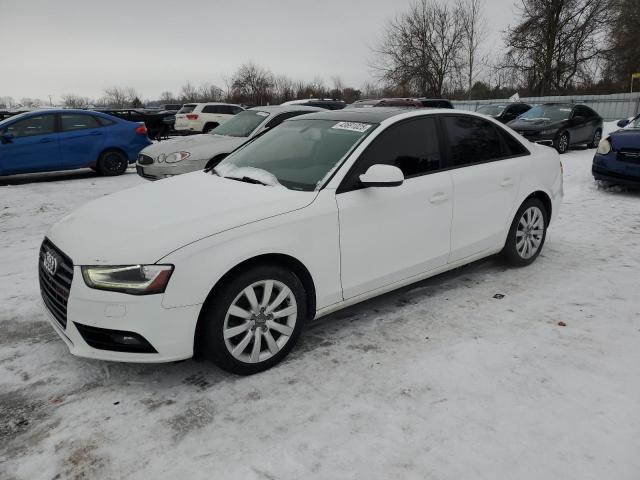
[0,109,151,175]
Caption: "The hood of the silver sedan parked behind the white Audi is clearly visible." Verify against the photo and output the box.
[140,134,248,160]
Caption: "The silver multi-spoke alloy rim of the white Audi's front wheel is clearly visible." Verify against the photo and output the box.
[223,280,298,363]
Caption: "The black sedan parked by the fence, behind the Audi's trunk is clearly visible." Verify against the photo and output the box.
[508,103,602,154]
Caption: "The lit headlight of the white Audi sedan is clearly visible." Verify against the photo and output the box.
[82,265,173,295]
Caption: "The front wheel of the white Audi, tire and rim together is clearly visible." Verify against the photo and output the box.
[196,265,307,375]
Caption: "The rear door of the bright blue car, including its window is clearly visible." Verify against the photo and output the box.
[59,112,108,169]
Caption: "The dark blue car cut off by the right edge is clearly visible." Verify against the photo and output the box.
[591,117,640,187]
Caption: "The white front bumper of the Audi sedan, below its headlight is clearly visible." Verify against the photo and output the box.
[43,266,201,363]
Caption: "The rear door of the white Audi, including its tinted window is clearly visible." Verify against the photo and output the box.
[442,115,529,262]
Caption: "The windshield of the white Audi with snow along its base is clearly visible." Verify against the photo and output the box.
[215,120,375,192]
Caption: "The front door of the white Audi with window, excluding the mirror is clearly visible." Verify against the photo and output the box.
[336,116,453,299]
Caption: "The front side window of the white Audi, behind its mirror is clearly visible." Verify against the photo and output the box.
[345,118,442,190]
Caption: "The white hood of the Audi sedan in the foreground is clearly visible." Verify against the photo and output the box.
[47,171,317,265]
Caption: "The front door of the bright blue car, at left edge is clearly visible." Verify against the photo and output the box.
[0,113,61,175]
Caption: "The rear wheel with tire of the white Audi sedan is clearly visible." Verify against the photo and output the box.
[502,198,549,267]
